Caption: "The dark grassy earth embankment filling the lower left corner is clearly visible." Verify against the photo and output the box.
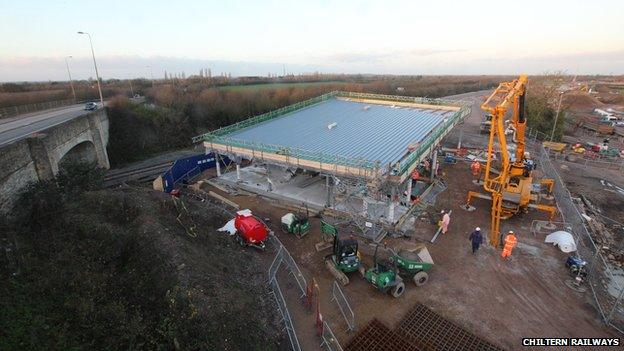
[0,188,284,350]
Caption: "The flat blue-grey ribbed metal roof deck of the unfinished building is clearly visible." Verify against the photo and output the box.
[224,98,455,166]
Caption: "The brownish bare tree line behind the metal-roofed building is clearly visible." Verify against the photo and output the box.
[108,75,502,165]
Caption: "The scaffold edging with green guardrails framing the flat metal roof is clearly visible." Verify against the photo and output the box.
[193,91,470,184]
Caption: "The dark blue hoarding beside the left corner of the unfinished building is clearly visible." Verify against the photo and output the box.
[162,153,230,193]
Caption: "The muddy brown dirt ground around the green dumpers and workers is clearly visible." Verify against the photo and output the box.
[213,163,611,350]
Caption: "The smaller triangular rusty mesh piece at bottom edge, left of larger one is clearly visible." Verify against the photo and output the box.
[345,318,421,351]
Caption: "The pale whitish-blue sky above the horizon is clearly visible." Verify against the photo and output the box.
[0,0,624,82]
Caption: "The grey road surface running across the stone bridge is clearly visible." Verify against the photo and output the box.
[0,104,98,147]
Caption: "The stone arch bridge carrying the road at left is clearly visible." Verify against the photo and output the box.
[0,105,110,213]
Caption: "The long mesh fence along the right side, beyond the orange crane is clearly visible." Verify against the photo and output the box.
[538,145,624,333]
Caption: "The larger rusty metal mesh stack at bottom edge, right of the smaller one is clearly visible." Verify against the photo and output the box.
[397,303,503,351]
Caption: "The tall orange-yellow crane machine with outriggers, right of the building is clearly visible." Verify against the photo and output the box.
[466,75,557,246]
